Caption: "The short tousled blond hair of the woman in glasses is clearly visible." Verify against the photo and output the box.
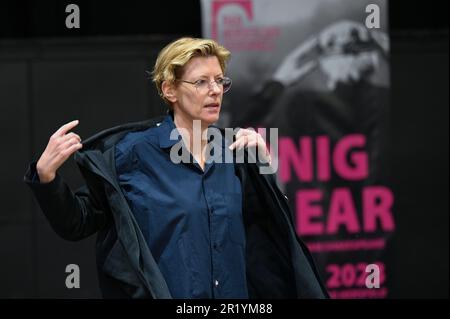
[152,38,231,105]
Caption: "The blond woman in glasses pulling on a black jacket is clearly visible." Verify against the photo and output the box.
[25,38,327,298]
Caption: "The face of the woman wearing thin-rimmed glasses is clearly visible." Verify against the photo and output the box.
[173,56,224,125]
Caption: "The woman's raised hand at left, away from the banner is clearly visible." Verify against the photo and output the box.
[36,120,83,183]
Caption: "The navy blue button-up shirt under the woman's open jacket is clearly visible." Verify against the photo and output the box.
[115,114,248,298]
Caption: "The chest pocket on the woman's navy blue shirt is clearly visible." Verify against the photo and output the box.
[224,194,245,245]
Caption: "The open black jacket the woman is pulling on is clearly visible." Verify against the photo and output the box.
[25,117,328,298]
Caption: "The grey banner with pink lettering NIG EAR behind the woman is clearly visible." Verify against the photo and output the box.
[201,0,396,298]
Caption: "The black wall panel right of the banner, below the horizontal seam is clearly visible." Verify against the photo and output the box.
[388,34,449,298]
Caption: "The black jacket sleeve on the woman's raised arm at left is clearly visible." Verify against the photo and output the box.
[24,162,108,241]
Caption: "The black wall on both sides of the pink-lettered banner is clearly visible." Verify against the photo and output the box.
[0,0,449,298]
